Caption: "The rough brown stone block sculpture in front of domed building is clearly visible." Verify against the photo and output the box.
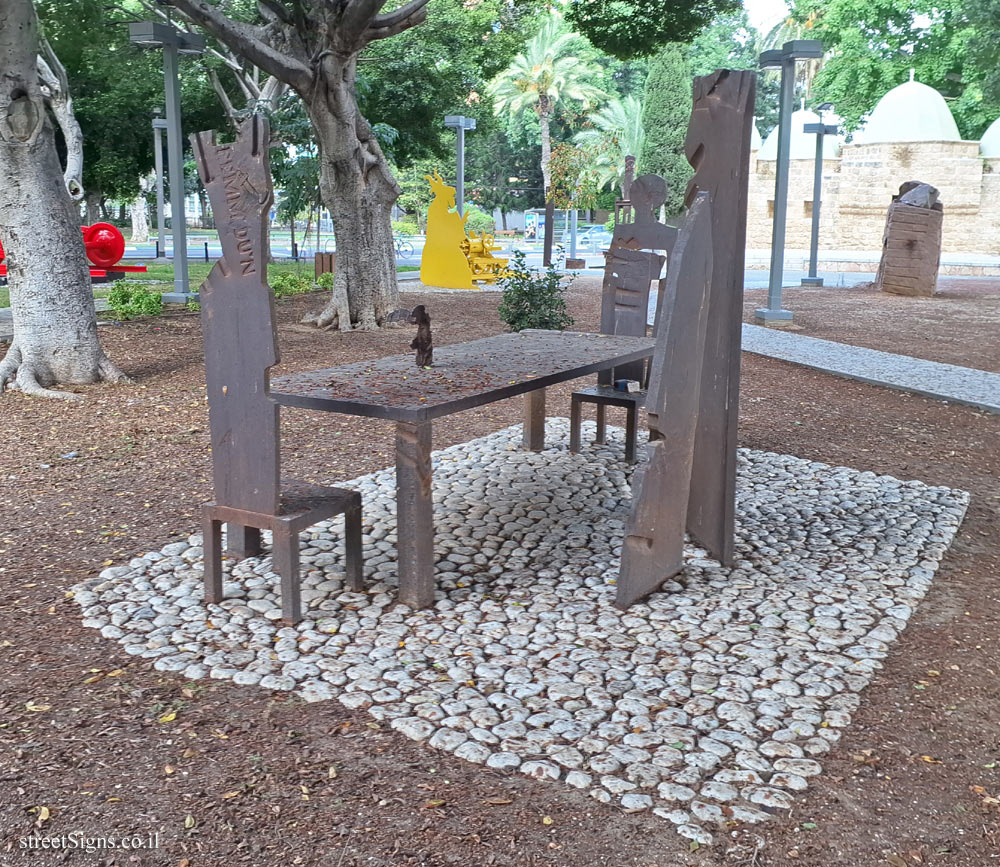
[875,181,944,297]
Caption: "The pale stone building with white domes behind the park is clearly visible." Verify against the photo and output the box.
[747,77,1000,258]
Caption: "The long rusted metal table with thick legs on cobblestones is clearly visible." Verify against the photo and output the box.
[271,330,655,608]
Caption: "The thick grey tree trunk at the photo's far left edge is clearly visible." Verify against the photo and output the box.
[0,0,124,397]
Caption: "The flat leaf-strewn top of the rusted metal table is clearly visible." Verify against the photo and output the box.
[270,330,655,423]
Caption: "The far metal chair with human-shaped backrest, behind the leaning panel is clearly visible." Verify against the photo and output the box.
[570,175,677,464]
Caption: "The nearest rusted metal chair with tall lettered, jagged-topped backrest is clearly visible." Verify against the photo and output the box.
[191,116,362,624]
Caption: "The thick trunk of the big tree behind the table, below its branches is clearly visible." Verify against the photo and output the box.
[305,53,400,331]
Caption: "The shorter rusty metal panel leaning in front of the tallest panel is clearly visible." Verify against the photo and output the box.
[615,194,712,608]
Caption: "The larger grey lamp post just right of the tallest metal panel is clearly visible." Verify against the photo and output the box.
[754,39,823,326]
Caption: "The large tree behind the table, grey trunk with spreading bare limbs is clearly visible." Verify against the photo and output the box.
[161,0,438,329]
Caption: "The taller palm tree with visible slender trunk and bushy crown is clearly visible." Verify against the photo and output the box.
[487,12,604,197]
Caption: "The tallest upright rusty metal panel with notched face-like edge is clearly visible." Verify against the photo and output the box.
[685,69,757,564]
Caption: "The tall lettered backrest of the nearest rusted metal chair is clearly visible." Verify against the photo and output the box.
[191,116,279,514]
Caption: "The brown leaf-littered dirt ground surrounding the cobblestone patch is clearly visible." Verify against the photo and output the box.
[0,279,1000,867]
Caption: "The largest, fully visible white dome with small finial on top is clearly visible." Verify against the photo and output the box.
[854,81,962,144]
